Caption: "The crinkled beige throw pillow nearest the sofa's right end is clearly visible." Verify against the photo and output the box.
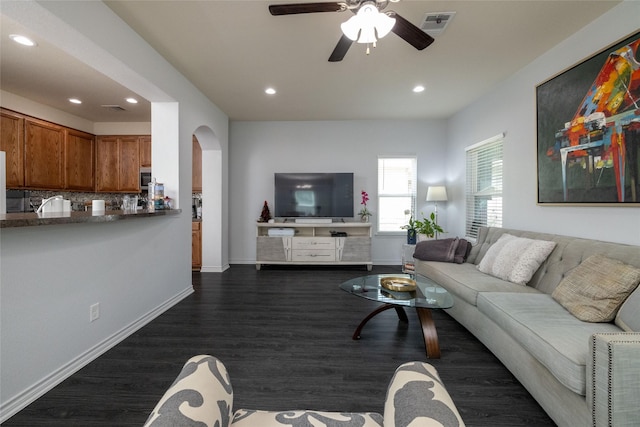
[551,255,640,322]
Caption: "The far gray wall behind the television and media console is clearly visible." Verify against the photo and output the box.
[229,120,447,264]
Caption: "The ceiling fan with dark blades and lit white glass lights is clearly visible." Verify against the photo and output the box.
[269,0,434,62]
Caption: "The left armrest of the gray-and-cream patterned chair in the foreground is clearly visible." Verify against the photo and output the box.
[144,355,233,427]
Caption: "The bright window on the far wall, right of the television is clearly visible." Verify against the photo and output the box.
[377,157,418,234]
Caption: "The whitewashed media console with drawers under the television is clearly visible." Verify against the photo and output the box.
[256,221,373,271]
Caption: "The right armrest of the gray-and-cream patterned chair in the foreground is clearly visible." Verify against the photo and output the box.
[384,362,464,427]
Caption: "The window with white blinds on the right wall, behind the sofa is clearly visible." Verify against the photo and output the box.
[465,134,504,238]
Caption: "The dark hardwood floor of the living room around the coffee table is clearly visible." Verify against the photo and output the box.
[3,265,554,427]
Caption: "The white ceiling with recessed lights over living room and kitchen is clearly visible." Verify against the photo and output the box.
[0,0,619,122]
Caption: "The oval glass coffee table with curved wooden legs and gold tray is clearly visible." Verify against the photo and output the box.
[340,274,453,359]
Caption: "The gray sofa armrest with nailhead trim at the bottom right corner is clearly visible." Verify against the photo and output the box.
[586,332,640,427]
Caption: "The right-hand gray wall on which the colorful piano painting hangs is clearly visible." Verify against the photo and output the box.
[447,1,640,245]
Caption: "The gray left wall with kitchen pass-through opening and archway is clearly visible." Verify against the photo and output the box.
[0,1,228,422]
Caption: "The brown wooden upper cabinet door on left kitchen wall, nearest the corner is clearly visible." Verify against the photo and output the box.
[64,129,95,191]
